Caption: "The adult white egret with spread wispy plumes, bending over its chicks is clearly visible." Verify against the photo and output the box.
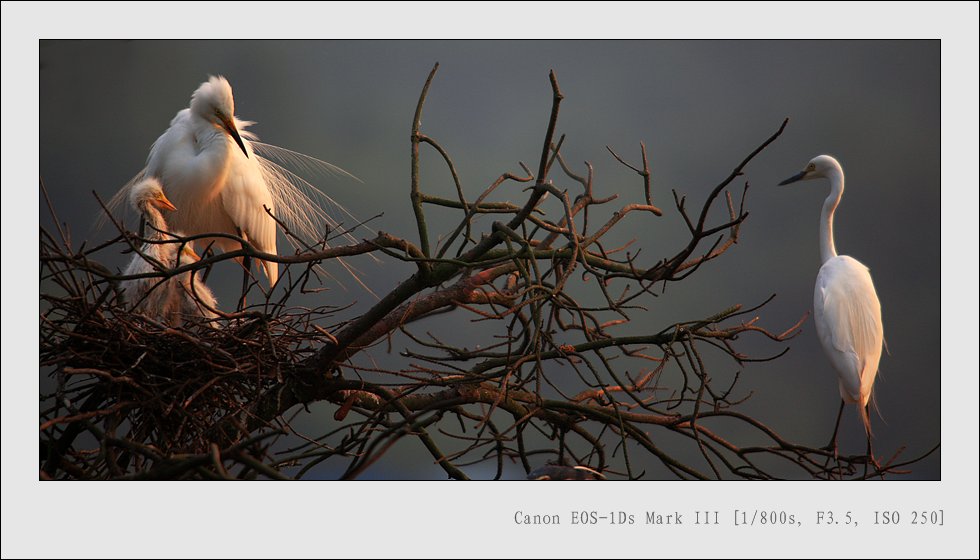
[110,76,364,294]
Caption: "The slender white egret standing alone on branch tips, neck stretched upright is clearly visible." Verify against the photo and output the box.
[779,155,884,455]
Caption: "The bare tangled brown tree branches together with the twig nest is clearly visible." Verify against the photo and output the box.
[39,69,935,480]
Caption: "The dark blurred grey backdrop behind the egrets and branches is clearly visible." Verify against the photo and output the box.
[39,40,941,479]
